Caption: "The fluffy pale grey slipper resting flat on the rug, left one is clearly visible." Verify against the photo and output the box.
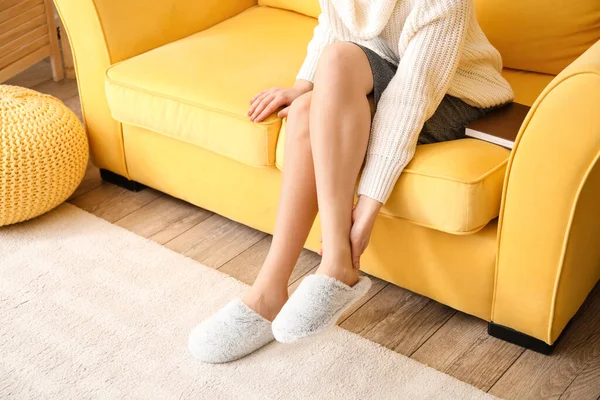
[188,299,274,364]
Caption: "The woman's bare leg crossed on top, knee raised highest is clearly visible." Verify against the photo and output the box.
[310,43,373,285]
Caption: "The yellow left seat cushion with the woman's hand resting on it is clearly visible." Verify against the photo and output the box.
[105,7,316,166]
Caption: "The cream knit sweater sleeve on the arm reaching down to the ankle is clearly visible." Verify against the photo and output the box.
[358,0,472,203]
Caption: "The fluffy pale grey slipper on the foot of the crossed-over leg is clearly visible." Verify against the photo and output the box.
[273,275,371,343]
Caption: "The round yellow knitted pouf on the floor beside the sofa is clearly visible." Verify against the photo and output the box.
[0,85,88,226]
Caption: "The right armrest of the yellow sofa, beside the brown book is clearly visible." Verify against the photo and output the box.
[491,41,600,344]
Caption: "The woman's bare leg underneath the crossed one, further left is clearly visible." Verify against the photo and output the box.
[244,92,317,320]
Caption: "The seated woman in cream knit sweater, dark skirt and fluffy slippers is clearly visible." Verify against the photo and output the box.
[189,0,513,362]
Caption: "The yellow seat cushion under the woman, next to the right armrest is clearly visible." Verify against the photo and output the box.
[276,124,510,235]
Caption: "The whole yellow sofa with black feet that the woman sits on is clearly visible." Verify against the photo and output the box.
[56,0,600,352]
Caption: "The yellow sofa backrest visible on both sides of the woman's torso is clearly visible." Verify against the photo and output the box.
[258,0,600,75]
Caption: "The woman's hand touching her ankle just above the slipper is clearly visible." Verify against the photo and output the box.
[350,196,383,269]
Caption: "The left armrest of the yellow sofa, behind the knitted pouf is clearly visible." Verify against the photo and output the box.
[55,0,257,177]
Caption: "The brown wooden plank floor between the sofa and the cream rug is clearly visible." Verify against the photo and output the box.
[7,62,600,400]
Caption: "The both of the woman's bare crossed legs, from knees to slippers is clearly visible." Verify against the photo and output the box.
[244,43,373,320]
